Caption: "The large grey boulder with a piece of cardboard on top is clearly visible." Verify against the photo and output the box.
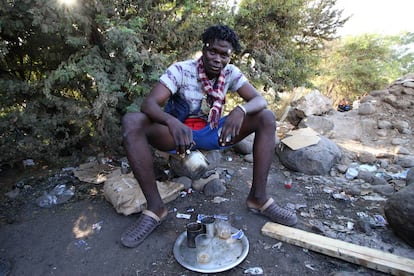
[276,136,342,175]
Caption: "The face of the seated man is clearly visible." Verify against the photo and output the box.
[203,39,233,79]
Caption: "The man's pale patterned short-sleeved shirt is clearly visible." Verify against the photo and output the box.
[160,59,247,116]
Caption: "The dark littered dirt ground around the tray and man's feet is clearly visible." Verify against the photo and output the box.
[0,148,414,275]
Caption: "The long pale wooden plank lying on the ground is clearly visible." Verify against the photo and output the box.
[262,222,414,275]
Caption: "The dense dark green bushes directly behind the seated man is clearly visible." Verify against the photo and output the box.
[0,0,344,164]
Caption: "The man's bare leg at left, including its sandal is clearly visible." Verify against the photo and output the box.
[121,113,178,247]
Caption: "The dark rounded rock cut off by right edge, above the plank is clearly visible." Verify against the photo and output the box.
[384,185,414,247]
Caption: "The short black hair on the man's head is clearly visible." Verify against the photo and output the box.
[201,25,241,53]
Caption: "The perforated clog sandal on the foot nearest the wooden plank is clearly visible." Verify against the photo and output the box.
[249,198,298,226]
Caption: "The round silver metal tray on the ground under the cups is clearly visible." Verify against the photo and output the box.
[173,228,249,273]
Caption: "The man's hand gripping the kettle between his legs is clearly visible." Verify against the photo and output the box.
[167,118,195,154]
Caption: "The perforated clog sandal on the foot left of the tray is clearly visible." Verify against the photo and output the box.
[121,210,161,248]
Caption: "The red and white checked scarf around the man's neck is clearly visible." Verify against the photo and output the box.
[197,57,226,128]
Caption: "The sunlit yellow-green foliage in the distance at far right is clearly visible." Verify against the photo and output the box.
[314,33,414,101]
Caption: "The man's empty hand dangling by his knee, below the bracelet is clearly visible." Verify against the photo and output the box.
[219,106,246,146]
